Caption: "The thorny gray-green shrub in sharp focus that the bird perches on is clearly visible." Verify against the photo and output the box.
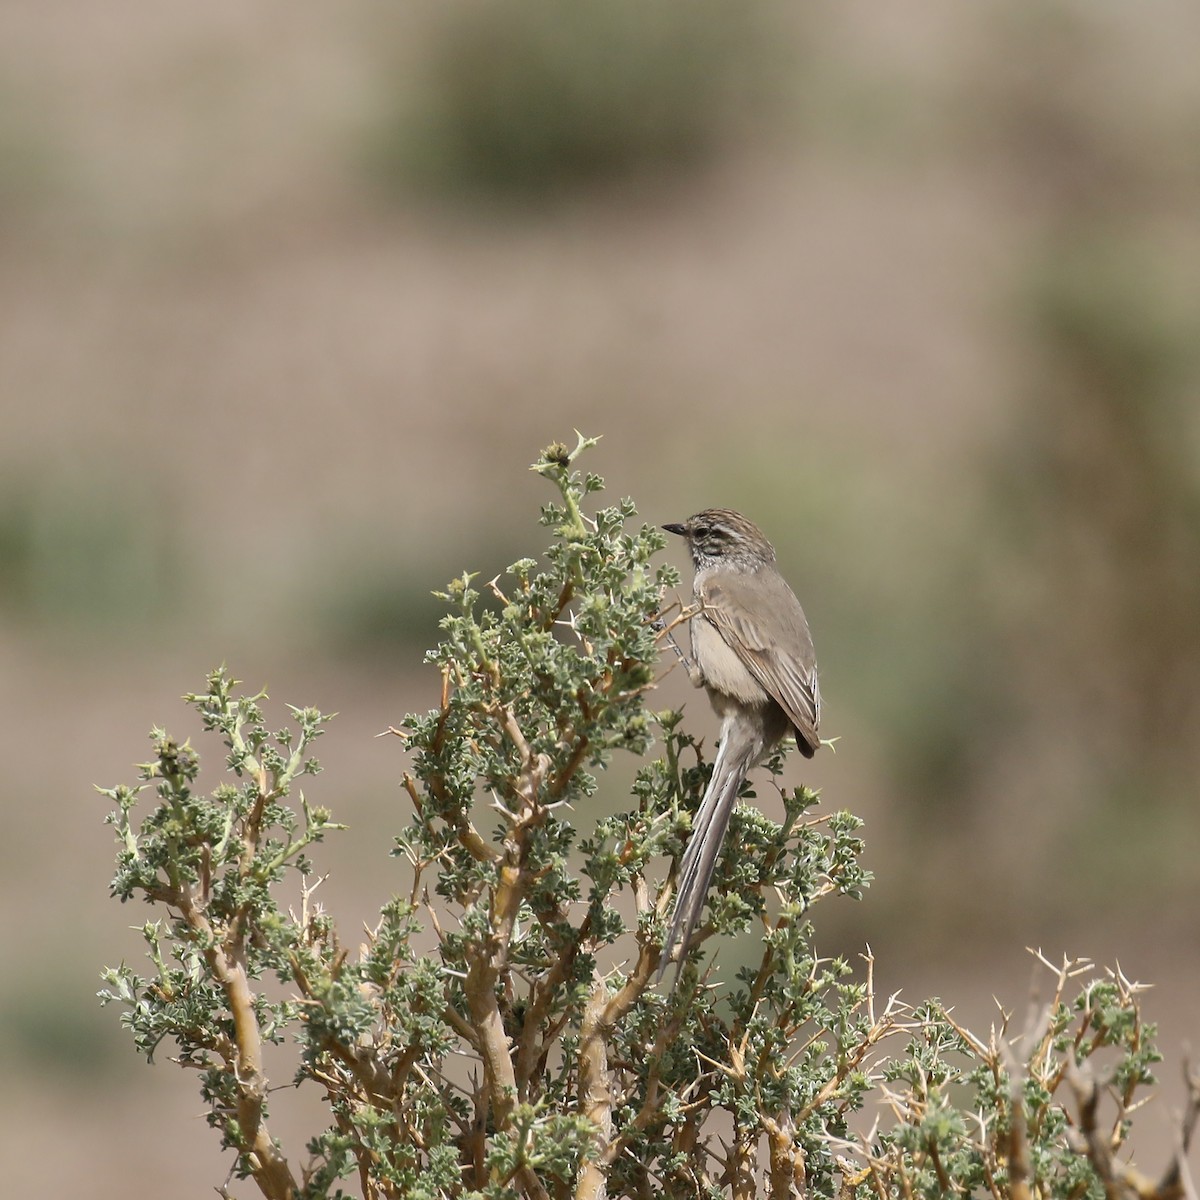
[101,438,1177,1200]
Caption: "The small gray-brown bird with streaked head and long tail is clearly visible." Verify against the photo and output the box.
[656,509,821,982]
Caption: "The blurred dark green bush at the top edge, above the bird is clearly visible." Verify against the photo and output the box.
[374,0,769,200]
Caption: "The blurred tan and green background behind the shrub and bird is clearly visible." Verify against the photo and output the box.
[0,0,1200,1198]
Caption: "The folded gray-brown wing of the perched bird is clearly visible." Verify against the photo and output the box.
[697,572,821,755]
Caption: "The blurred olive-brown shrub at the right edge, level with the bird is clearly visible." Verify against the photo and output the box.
[996,235,1200,802]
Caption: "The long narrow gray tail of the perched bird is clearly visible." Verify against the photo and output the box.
[658,732,756,982]
